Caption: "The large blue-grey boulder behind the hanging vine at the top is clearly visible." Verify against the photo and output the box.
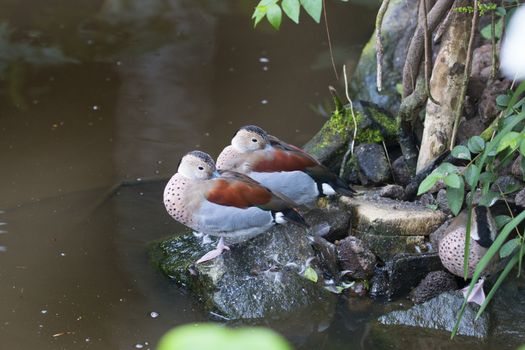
[350,0,418,115]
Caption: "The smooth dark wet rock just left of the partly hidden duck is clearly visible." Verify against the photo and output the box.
[386,253,443,298]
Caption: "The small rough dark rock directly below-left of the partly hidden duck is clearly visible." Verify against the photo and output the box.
[409,271,458,304]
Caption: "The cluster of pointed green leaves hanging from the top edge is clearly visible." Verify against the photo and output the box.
[252,0,323,29]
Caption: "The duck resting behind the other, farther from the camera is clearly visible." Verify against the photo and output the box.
[217,125,355,205]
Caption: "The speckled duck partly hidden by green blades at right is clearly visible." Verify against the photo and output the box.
[438,205,498,305]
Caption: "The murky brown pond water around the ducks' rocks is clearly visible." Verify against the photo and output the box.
[0,0,516,349]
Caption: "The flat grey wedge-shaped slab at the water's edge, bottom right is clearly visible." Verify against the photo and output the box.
[378,292,489,338]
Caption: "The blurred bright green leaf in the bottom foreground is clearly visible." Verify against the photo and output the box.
[157,323,292,350]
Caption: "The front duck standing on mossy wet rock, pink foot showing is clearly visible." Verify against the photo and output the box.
[163,151,308,263]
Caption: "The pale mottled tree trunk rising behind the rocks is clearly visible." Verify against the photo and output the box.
[417,1,470,172]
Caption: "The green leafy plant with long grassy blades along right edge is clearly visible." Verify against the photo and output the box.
[418,82,525,335]
